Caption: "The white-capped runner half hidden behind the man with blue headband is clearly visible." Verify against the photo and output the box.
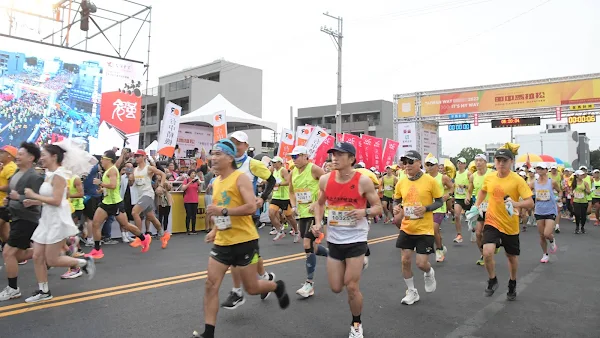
[220,131,276,310]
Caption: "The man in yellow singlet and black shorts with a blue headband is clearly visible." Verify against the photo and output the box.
[193,139,290,338]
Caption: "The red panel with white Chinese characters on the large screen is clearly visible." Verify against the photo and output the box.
[100,92,142,134]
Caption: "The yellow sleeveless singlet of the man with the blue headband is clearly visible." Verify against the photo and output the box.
[213,170,258,246]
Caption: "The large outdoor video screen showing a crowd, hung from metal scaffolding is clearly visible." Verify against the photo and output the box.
[0,35,144,154]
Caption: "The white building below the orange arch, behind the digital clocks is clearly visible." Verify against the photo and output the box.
[515,123,590,168]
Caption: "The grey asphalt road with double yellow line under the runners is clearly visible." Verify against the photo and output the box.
[0,221,600,338]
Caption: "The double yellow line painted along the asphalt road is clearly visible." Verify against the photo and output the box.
[0,235,398,318]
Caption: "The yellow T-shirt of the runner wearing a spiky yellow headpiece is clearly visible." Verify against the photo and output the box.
[481,172,533,235]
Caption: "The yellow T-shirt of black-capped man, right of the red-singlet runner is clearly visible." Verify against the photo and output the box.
[394,174,444,236]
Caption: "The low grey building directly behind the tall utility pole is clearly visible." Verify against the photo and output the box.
[296,100,394,139]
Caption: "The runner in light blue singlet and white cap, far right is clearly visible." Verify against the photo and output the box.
[529,163,560,263]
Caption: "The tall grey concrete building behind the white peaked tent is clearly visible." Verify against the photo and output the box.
[140,60,262,149]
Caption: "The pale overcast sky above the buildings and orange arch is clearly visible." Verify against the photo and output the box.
[0,0,600,156]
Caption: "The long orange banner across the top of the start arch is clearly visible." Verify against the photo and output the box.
[420,79,600,116]
